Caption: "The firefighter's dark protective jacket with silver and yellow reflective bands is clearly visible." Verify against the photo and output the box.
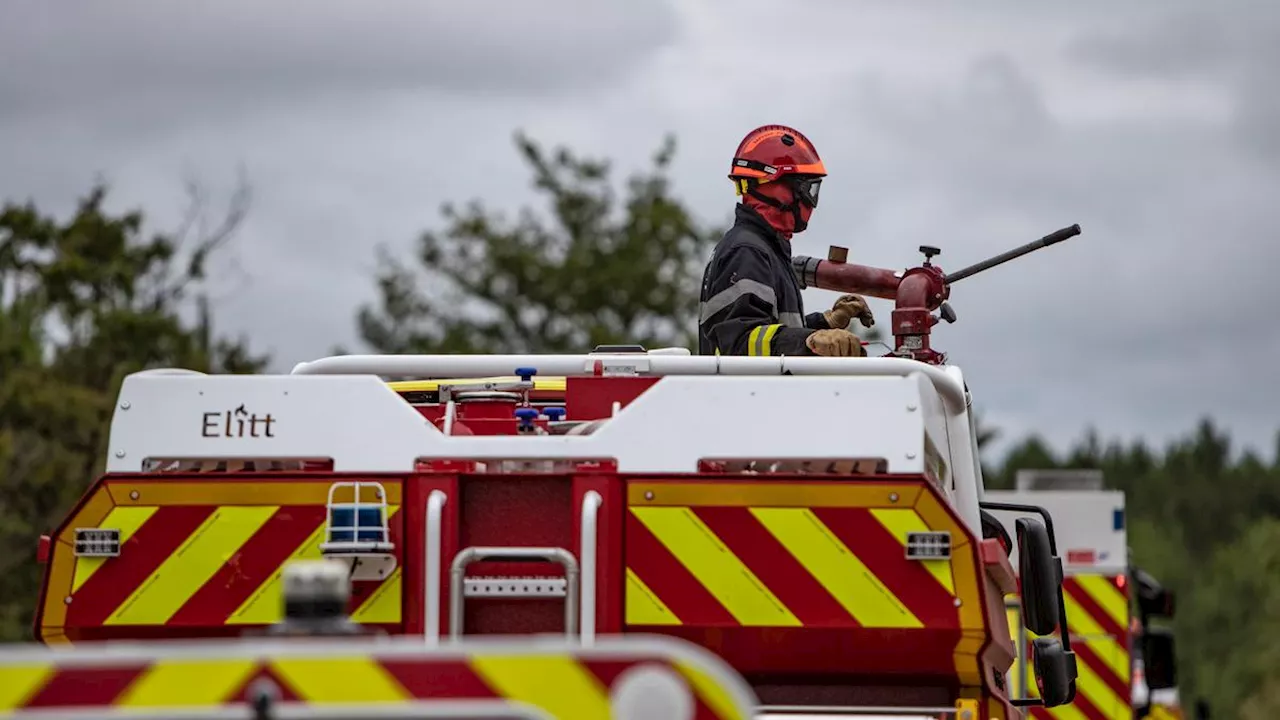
[698,204,829,355]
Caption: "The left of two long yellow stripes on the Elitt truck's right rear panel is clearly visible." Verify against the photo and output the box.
[631,507,801,626]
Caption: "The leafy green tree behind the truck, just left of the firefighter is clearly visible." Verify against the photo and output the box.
[358,135,723,354]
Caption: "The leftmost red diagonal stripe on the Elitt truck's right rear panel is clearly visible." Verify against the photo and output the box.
[626,512,739,626]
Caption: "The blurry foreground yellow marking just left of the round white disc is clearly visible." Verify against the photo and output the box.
[471,655,612,720]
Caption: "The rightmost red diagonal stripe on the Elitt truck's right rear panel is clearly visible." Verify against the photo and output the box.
[813,507,977,629]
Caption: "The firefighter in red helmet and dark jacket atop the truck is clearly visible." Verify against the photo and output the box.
[698,126,876,357]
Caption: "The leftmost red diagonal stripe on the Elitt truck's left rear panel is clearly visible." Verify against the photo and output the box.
[67,505,216,626]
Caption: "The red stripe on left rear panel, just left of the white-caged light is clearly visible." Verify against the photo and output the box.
[166,505,327,625]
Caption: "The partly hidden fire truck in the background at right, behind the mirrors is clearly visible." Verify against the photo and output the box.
[987,469,1183,720]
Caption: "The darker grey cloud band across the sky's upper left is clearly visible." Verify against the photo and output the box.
[0,0,677,122]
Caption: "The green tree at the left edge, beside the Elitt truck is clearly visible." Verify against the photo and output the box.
[0,183,266,639]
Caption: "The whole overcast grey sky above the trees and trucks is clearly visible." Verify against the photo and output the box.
[0,0,1280,456]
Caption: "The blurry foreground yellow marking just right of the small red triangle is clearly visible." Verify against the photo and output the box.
[270,656,412,703]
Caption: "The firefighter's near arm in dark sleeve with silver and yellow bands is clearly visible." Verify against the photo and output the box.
[698,246,813,355]
